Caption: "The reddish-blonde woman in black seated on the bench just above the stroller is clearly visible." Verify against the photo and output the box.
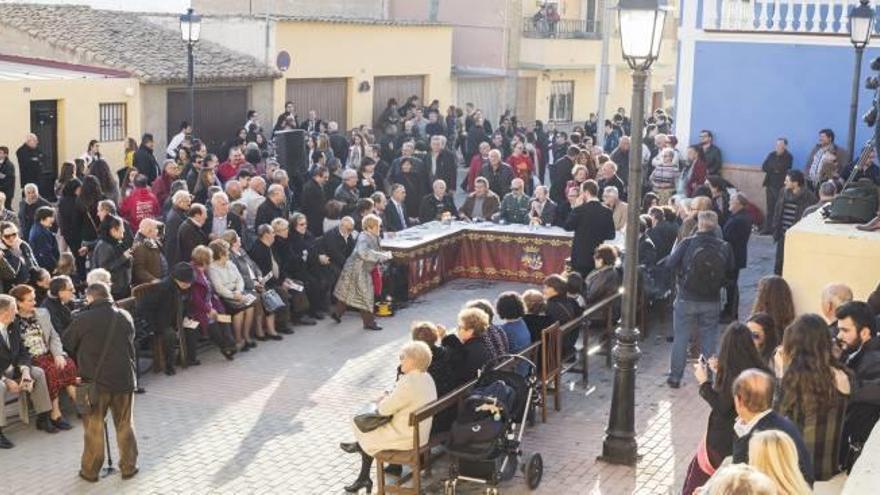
[443,308,491,387]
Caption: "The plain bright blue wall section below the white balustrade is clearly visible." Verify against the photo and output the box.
[690,41,880,166]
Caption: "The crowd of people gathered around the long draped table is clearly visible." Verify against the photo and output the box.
[0,92,880,492]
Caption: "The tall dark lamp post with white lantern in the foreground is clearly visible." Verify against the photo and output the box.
[600,0,668,465]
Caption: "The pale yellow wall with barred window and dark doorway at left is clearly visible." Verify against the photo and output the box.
[0,79,141,199]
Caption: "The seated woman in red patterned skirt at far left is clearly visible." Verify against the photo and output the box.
[9,285,79,430]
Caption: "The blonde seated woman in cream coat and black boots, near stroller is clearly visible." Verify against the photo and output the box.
[340,342,437,493]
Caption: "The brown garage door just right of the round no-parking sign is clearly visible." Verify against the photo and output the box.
[287,78,348,129]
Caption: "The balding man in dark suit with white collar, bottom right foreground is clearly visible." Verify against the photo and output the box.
[733,368,813,486]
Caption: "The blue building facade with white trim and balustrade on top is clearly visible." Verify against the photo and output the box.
[676,0,880,211]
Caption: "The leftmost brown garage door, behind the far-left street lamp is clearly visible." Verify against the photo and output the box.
[168,87,248,157]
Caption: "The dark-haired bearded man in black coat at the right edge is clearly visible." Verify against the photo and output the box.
[835,301,880,472]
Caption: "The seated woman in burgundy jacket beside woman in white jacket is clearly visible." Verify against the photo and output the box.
[187,246,236,361]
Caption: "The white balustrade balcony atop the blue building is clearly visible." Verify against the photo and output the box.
[698,0,880,36]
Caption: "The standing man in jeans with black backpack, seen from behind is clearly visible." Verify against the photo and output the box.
[665,211,735,388]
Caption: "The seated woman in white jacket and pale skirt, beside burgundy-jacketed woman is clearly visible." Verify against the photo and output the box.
[208,239,257,352]
